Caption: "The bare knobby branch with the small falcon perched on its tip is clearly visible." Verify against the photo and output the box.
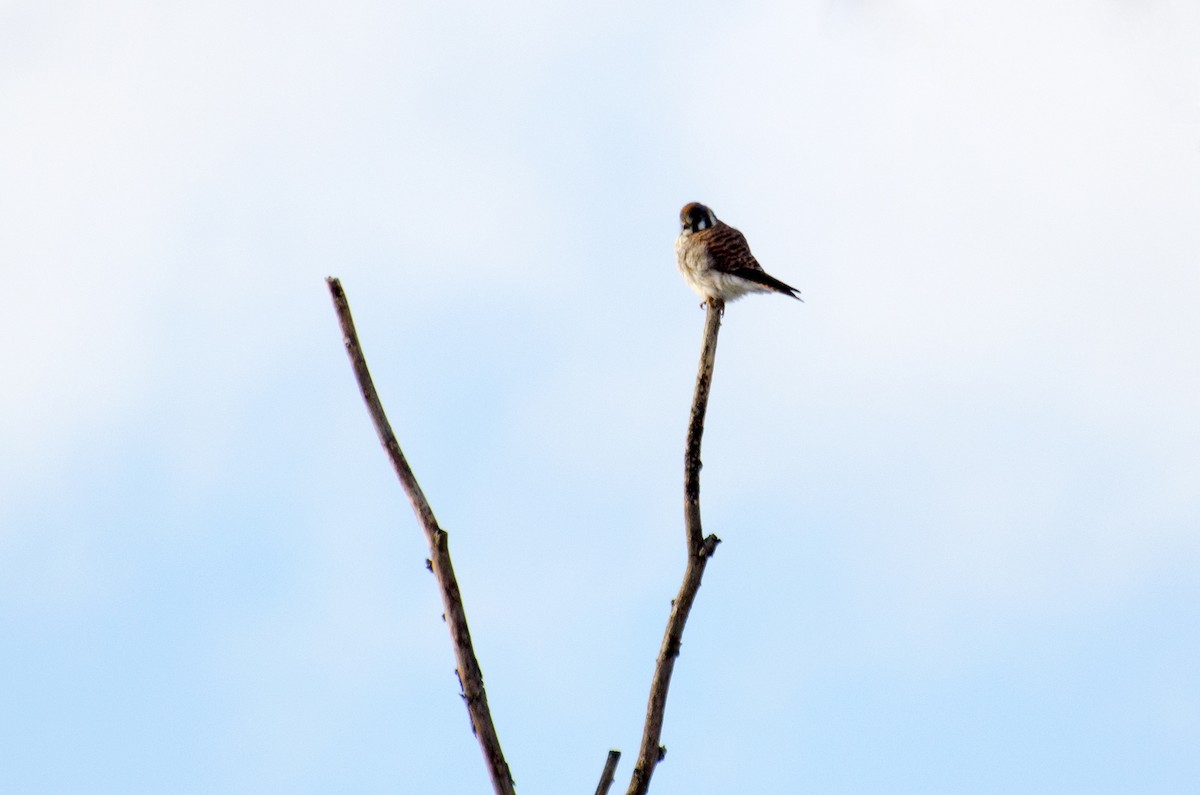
[628,299,725,795]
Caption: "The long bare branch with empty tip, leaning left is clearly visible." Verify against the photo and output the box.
[325,276,516,795]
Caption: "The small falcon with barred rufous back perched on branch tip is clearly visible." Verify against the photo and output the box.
[676,202,802,301]
